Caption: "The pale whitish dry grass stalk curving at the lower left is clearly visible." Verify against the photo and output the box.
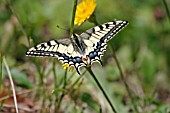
[3,57,19,113]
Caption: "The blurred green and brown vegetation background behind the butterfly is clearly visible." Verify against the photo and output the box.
[0,0,170,113]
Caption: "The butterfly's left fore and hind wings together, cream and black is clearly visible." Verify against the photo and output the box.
[26,39,86,74]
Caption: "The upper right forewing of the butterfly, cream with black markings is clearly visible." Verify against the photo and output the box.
[80,20,128,45]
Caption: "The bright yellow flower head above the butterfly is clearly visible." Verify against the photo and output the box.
[74,0,96,25]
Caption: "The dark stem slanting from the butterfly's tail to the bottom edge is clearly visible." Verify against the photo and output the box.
[86,67,117,113]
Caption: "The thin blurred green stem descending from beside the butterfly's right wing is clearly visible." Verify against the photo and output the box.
[111,47,139,113]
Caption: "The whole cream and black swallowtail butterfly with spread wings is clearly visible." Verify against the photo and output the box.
[26,20,128,75]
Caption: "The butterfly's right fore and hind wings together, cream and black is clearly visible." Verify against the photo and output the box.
[80,20,128,64]
